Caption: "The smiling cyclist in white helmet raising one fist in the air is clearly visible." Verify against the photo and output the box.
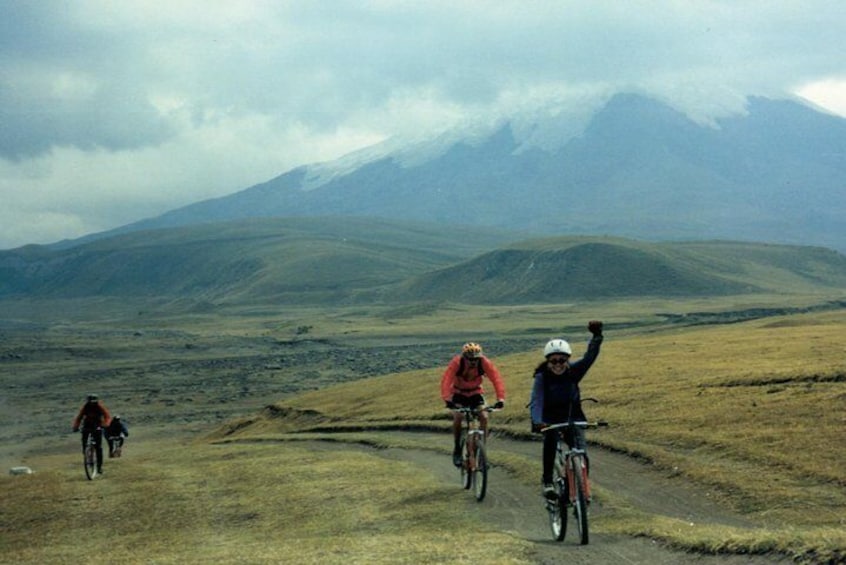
[529,320,602,497]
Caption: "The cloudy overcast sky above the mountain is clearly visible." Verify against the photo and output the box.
[0,0,846,249]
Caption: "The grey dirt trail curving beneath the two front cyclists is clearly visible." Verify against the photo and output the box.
[322,432,790,565]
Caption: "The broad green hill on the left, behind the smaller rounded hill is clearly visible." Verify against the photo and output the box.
[0,218,514,303]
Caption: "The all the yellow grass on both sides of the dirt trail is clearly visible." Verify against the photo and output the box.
[0,306,846,563]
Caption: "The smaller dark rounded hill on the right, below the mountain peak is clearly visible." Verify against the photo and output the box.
[398,237,846,304]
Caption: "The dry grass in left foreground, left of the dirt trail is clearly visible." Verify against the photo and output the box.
[0,442,529,564]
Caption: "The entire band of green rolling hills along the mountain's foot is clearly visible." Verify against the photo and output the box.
[0,218,846,305]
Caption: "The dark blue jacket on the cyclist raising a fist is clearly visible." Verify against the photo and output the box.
[529,335,602,424]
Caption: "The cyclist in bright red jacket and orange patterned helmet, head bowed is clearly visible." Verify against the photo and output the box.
[441,342,505,467]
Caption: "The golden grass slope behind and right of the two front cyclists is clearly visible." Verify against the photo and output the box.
[237,311,846,555]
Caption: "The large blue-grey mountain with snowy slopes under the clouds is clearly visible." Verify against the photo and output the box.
[61,94,846,251]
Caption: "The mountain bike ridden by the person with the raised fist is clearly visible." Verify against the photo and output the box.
[541,421,608,545]
